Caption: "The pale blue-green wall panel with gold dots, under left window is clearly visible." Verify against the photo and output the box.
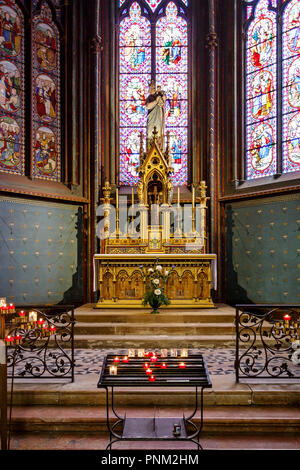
[0,197,83,305]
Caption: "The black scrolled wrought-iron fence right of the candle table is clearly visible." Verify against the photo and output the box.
[235,304,300,382]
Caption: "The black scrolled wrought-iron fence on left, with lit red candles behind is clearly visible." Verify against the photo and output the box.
[5,305,75,382]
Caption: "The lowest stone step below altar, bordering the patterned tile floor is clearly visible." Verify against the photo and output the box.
[74,330,235,349]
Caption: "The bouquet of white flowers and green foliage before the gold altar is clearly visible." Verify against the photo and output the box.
[140,260,175,313]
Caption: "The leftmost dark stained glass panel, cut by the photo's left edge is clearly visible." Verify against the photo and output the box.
[0,0,25,175]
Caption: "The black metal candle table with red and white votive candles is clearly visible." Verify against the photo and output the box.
[98,354,211,450]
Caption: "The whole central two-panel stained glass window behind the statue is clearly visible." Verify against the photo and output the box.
[119,0,189,186]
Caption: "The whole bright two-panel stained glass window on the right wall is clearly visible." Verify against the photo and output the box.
[244,0,300,180]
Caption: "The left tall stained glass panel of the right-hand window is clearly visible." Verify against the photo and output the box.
[246,0,277,179]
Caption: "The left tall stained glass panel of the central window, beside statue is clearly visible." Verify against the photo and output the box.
[119,2,151,185]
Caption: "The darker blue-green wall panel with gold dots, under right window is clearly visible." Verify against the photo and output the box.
[226,194,300,304]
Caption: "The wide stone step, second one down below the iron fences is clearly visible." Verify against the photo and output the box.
[8,406,300,435]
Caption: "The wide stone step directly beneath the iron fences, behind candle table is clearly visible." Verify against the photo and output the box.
[8,372,300,409]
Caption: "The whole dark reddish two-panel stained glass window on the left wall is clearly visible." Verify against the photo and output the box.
[0,0,61,182]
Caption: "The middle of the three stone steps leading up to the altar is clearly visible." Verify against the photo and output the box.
[75,319,234,336]
